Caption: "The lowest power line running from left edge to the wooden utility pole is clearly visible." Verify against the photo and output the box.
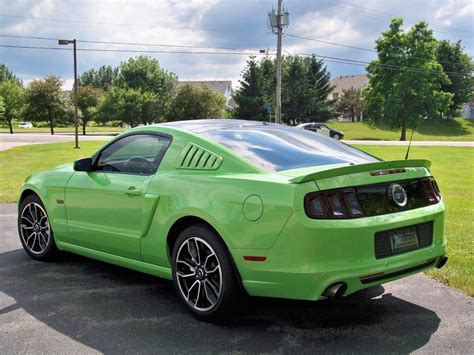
[0,44,273,56]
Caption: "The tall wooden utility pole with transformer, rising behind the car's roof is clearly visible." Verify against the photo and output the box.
[268,0,290,123]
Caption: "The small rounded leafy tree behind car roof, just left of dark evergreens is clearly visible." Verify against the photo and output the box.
[169,84,226,121]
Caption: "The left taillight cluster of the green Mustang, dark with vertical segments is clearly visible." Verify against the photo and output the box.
[304,188,364,219]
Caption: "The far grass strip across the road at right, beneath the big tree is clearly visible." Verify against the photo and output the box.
[328,118,474,141]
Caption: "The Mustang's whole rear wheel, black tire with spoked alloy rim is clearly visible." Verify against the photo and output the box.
[172,224,241,322]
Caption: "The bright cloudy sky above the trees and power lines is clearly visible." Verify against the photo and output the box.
[0,0,474,87]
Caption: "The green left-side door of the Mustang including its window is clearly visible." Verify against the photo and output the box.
[65,133,171,259]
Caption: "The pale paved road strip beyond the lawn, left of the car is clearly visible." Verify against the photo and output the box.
[0,133,112,151]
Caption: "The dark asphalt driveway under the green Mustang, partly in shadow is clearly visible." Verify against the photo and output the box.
[0,204,474,354]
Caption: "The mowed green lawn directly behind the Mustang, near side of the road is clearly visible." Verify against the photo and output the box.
[0,142,474,295]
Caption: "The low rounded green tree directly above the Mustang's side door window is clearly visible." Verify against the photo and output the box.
[95,88,158,127]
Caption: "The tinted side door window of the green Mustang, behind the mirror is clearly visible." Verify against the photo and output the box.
[95,134,171,175]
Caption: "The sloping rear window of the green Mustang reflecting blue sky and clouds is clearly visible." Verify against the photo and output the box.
[201,124,378,172]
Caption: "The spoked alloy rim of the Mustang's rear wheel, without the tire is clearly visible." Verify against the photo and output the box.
[175,237,222,311]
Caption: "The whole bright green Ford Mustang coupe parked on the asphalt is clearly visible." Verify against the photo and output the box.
[18,120,447,320]
